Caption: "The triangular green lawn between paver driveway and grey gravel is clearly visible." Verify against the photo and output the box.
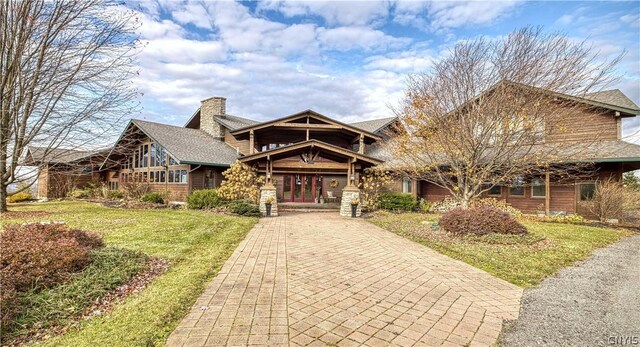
[369,212,629,287]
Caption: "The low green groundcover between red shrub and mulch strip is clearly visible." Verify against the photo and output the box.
[4,247,148,342]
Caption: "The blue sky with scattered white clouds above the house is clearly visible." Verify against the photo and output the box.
[127,0,640,143]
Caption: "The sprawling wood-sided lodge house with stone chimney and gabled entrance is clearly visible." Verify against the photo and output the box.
[69,86,640,215]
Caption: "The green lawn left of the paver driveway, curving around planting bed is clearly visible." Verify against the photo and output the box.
[1,202,258,346]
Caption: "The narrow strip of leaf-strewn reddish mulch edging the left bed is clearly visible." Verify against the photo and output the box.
[2,257,169,347]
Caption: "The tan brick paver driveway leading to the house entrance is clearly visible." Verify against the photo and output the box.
[167,212,522,346]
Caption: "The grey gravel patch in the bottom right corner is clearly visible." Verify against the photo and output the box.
[501,235,640,346]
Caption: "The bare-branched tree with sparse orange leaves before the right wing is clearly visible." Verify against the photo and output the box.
[388,27,621,206]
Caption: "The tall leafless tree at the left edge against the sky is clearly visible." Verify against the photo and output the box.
[0,0,138,212]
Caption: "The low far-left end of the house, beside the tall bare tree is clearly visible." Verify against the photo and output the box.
[23,146,109,199]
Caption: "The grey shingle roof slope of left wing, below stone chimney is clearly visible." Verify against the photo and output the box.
[131,119,238,165]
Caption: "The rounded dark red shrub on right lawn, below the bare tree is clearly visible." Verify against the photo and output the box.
[440,206,527,235]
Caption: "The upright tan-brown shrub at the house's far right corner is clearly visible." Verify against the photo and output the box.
[580,178,626,223]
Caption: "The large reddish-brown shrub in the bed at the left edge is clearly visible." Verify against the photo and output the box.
[0,224,103,291]
